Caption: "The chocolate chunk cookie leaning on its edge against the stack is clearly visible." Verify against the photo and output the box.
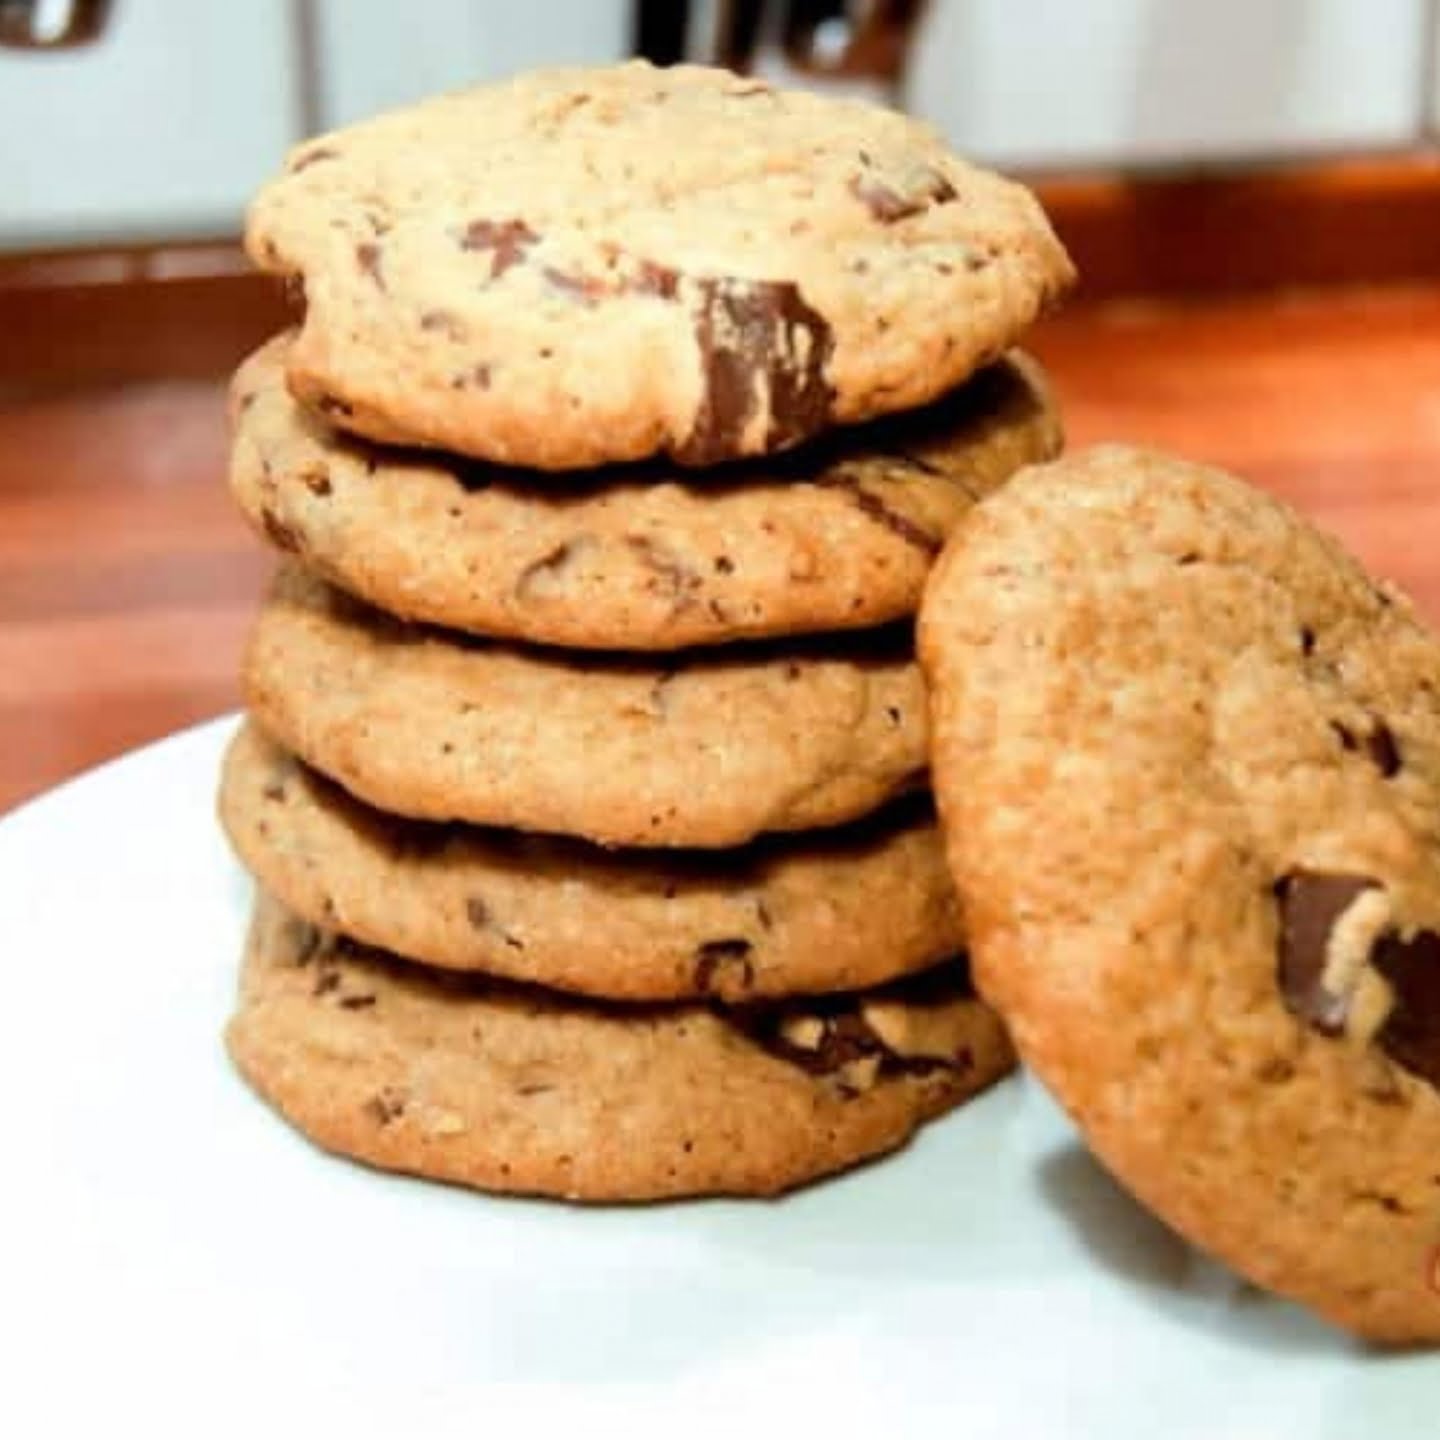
[920,448,1440,1341]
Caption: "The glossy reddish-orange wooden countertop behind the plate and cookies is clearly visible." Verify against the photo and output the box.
[0,280,1440,811]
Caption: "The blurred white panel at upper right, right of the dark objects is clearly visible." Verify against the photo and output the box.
[907,0,1430,167]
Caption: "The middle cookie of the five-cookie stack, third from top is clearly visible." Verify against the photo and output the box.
[243,564,927,848]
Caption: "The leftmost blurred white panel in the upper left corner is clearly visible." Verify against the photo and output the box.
[0,0,300,249]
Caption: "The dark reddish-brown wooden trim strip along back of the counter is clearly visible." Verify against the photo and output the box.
[0,154,1440,392]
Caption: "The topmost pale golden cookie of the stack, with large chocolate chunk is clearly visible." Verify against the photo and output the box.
[246,62,1073,469]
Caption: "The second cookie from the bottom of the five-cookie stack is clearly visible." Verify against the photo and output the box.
[220,726,962,1001]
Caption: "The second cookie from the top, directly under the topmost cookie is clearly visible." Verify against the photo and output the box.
[230,338,1060,649]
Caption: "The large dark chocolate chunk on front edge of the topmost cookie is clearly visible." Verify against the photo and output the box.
[675,278,835,465]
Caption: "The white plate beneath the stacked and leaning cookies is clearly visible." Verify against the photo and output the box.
[0,720,1440,1440]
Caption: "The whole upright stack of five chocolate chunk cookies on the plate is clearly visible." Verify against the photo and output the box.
[213,65,1070,1200]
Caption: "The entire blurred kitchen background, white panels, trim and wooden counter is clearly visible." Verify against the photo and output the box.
[0,0,1440,811]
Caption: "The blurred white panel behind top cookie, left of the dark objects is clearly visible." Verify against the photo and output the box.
[317,0,631,128]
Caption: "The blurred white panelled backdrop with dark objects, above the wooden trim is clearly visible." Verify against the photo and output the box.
[0,0,1440,249]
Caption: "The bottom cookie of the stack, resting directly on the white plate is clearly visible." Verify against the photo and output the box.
[226,896,1014,1201]
